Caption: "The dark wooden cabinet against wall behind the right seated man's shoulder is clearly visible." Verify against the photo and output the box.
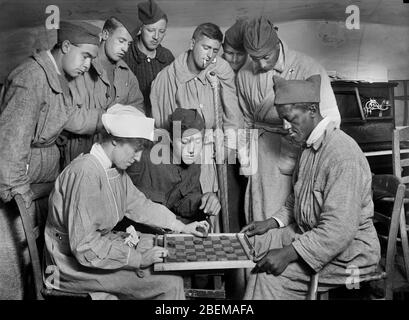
[331,81,398,151]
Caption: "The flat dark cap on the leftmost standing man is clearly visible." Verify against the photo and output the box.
[57,21,101,45]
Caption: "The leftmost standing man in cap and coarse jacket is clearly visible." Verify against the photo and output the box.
[0,21,102,299]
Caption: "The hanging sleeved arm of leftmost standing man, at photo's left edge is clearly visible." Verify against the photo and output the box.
[0,69,39,201]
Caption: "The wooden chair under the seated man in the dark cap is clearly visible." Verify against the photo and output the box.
[307,175,409,300]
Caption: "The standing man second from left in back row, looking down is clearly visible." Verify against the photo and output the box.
[62,17,145,167]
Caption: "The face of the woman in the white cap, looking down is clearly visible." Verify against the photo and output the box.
[112,140,143,170]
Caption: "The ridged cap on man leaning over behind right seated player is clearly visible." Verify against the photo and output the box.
[243,16,280,57]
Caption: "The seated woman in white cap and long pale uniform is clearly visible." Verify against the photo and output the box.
[45,108,208,299]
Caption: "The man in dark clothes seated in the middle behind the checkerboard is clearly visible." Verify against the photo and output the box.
[127,108,221,223]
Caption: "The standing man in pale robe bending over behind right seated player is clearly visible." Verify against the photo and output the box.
[236,16,340,222]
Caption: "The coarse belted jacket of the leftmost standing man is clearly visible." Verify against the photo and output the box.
[0,51,102,201]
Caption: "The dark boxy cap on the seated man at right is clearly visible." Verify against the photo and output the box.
[273,74,321,104]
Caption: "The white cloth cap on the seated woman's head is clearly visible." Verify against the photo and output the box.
[102,106,155,141]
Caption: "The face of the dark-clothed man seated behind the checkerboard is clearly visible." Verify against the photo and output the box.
[173,129,203,165]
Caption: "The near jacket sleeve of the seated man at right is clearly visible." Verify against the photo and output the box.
[292,160,368,271]
